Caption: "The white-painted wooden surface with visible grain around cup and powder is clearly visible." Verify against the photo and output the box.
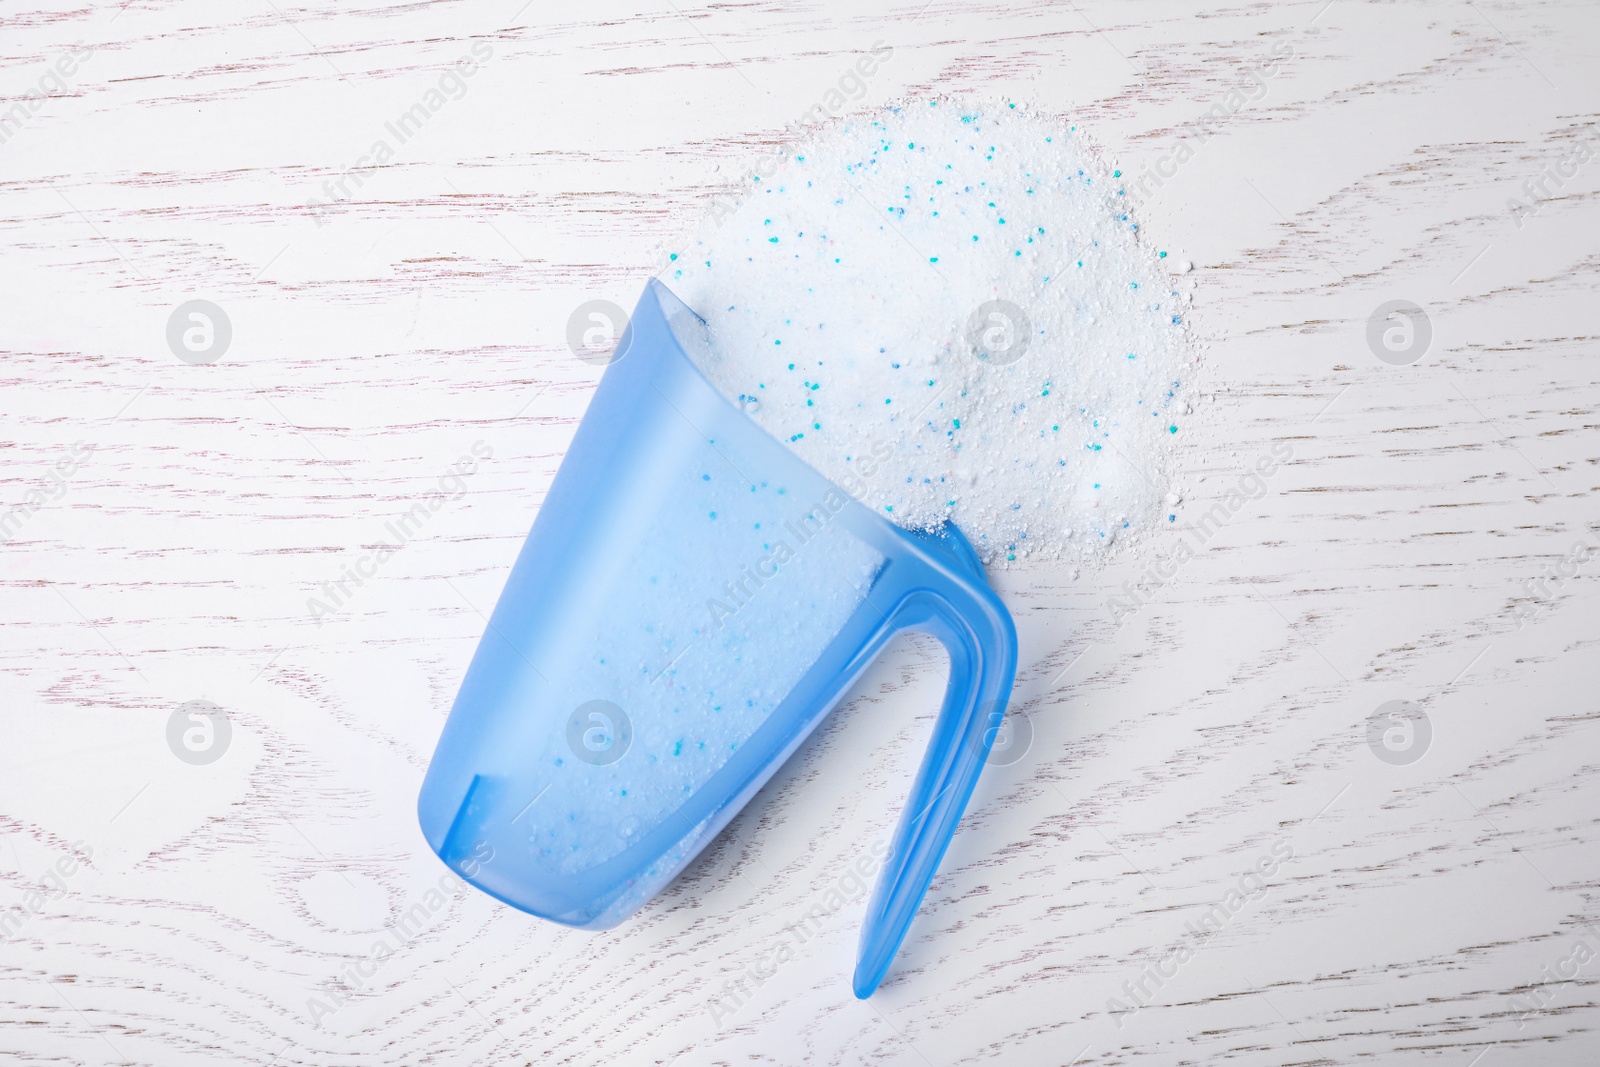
[0,0,1600,1067]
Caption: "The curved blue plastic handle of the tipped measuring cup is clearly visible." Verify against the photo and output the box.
[853,572,1016,1000]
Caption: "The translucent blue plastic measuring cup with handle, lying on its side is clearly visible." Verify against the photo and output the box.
[418,280,1016,998]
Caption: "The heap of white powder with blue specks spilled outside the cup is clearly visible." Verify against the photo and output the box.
[662,99,1194,561]
